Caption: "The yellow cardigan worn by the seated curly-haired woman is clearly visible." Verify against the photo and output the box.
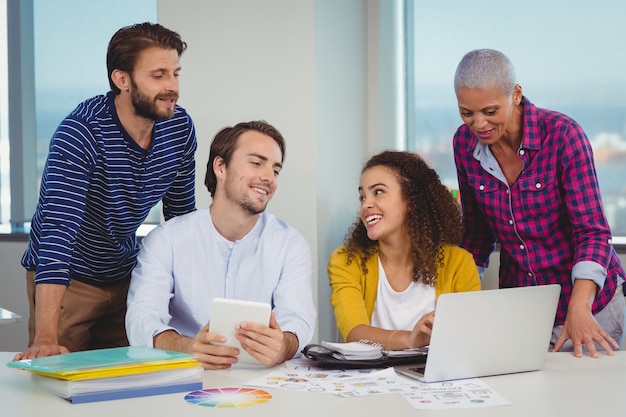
[328,245,480,340]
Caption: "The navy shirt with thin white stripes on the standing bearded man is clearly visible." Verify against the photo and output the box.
[22,92,197,285]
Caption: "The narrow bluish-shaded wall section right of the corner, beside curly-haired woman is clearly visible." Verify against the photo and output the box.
[310,1,368,340]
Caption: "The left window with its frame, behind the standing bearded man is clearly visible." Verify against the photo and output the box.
[0,0,160,225]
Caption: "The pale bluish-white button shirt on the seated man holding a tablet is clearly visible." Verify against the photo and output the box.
[126,209,316,352]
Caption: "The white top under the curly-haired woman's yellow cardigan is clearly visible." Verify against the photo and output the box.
[372,257,436,330]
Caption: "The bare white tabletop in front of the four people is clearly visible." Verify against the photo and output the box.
[0,351,626,417]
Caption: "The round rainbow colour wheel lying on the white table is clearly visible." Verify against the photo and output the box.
[185,388,272,408]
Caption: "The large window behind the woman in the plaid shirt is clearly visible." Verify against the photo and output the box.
[405,0,626,244]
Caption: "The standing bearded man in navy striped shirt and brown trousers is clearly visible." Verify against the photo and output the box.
[15,23,197,359]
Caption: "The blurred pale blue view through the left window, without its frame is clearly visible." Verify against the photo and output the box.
[0,0,160,224]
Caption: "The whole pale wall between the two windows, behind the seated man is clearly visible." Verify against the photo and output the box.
[158,0,367,338]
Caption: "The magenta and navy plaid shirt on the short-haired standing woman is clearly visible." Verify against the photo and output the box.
[453,98,624,325]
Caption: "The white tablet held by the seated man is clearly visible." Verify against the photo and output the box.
[209,298,272,364]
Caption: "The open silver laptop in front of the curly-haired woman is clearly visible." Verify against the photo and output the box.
[395,284,561,382]
